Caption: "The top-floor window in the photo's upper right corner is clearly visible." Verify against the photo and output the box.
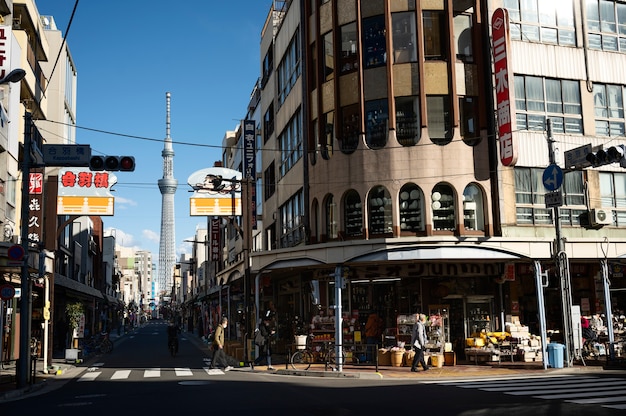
[587,0,626,52]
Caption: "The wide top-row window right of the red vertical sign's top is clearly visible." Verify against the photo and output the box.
[504,0,576,46]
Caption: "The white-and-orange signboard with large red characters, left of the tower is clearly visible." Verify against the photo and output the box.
[57,168,117,216]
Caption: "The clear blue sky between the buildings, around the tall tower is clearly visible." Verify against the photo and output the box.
[36,0,272,261]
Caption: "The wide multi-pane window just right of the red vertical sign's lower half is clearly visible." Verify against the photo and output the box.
[515,75,583,134]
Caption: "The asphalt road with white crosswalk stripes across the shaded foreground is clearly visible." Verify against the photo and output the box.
[0,321,626,416]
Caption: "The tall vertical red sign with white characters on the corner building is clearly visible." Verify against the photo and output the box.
[491,8,517,166]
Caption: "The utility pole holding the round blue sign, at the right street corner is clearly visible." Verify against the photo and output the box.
[546,118,574,367]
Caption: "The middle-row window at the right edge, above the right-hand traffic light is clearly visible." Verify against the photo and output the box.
[593,83,624,137]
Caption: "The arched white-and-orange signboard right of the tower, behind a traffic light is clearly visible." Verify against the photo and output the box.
[187,167,242,217]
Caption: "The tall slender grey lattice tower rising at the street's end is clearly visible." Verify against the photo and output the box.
[158,92,178,295]
